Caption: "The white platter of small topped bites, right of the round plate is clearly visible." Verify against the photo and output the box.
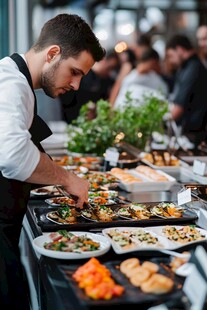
[102,225,207,254]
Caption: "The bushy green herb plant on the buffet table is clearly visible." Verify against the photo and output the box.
[68,93,168,156]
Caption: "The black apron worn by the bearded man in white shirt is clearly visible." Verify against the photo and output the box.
[0,53,52,310]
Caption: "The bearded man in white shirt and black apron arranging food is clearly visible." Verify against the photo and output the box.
[0,14,105,310]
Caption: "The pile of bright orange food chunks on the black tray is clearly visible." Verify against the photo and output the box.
[72,257,124,300]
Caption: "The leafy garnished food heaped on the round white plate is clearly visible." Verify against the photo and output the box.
[44,230,100,253]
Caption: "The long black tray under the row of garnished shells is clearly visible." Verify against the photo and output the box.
[29,203,198,232]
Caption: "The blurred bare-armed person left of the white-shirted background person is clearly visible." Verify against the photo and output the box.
[109,48,137,104]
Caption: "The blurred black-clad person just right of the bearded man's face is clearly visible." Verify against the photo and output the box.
[59,49,120,123]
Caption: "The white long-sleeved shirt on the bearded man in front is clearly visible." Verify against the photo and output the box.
[0,57,40,181]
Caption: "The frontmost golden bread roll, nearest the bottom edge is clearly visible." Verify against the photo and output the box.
[140,273,174,295]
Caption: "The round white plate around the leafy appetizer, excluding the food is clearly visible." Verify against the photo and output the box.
[32,231,110,259]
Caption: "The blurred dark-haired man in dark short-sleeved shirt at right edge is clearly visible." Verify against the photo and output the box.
[166,34,207,145]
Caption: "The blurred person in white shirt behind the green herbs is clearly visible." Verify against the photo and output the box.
[111,48,168,108]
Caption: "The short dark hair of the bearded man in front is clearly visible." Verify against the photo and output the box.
[33,14,106,61]
